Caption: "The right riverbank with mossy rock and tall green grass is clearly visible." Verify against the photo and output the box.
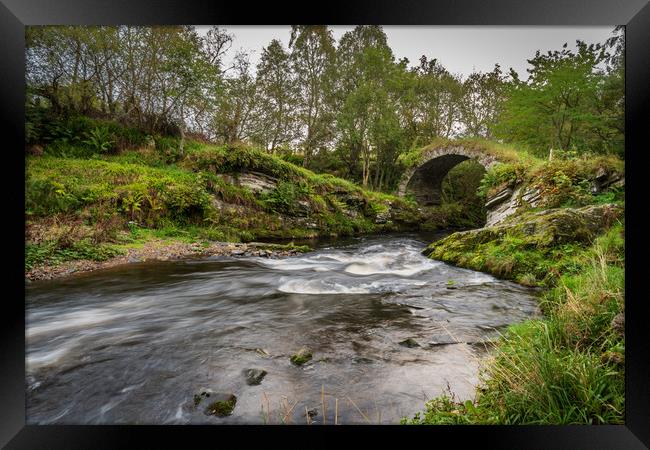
[402,199,625,424]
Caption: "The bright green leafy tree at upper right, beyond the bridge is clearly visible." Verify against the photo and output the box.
[493,41,614,155]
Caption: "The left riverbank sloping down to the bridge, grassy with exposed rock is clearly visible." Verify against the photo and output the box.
[25,117,486,270]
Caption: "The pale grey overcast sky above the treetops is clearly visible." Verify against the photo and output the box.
[197,25,614,78]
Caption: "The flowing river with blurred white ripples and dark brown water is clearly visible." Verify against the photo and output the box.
[26,235,539,424]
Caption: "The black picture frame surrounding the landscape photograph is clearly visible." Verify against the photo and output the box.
[0,0,650,449]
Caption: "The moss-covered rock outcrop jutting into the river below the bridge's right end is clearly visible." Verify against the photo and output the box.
[422,204,624,286]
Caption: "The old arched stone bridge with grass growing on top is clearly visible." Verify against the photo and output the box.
[397,145,499,206]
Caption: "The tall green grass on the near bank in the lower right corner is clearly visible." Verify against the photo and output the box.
[402,224,625,424]
